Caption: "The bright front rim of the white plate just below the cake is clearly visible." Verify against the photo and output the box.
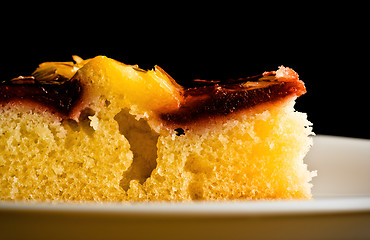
[0,197,370,217]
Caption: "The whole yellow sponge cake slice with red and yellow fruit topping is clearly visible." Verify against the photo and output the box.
[0,56,316,202]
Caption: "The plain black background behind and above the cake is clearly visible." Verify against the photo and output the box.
[1,3,370,138]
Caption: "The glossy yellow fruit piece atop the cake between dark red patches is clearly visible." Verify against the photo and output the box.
[33,56,182,115]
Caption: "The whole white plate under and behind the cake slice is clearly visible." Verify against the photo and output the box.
[0,136,370,239]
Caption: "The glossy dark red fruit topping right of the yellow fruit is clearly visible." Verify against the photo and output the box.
[160,72,306,126]
